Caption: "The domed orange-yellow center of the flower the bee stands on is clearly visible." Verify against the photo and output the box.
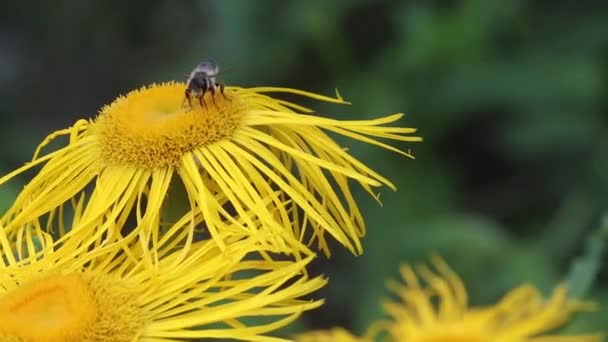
[91,83,245,169]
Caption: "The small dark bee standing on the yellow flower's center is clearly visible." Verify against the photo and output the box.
[185,60,227,107]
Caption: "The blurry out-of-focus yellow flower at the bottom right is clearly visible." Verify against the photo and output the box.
[385,257,602,342]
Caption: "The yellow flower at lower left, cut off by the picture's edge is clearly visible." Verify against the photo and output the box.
[0,223,325,342]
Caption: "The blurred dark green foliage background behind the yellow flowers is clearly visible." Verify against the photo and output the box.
[0,0,608,333]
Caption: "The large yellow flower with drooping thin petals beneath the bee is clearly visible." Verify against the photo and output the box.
[0,83,421,254]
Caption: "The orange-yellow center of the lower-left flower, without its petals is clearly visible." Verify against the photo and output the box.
[0,273,142,342]
